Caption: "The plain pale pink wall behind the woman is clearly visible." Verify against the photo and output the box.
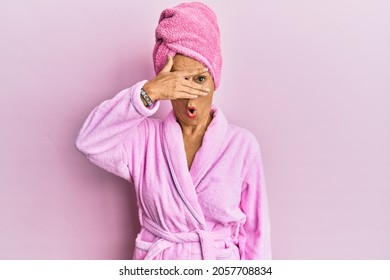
[0,0,390,259]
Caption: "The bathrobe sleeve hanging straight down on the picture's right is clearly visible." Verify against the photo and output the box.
[238,140,272,260]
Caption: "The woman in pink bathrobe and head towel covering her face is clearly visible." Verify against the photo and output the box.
[76,3,271,259]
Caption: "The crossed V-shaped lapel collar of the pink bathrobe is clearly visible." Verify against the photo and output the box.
[163,106,228,230]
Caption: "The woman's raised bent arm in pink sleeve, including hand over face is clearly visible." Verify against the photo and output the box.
[76,56,210,180]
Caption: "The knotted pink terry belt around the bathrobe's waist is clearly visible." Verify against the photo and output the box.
[138,217,232,260]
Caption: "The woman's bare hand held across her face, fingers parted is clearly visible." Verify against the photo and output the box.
[143,55,210,102]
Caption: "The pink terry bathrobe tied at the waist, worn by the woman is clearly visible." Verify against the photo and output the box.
[76,81,271,259]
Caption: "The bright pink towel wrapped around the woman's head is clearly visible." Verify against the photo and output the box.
[153,2,222,89]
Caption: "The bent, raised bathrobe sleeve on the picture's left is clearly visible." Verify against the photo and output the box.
[76,81,159,181]
